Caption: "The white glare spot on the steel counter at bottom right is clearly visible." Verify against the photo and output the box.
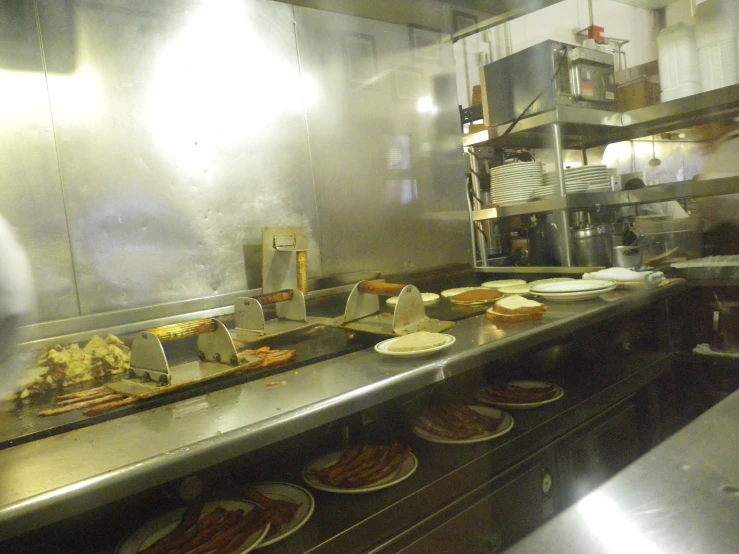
[578,492,662,554]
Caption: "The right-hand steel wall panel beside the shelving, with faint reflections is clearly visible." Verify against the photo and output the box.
[295,8,470,274]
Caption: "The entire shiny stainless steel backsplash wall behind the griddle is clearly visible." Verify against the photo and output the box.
[0,0,470,328]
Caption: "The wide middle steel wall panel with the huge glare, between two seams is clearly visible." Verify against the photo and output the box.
[44,0,321,314]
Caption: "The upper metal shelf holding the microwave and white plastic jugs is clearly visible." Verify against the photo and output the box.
[462,85,739,150]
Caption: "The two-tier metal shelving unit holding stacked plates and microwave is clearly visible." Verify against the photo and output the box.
[462,85,739,268]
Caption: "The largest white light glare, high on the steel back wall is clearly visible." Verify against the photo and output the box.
[146,0,319,172]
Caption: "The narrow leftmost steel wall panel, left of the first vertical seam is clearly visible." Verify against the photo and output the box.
[0,52,79,321]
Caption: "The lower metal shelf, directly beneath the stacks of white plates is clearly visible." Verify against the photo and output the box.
[472,176,739,221]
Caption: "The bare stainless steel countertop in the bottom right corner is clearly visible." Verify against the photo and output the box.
[507,384,739,554]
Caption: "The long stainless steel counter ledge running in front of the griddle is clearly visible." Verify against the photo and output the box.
[0,282,685,540]
